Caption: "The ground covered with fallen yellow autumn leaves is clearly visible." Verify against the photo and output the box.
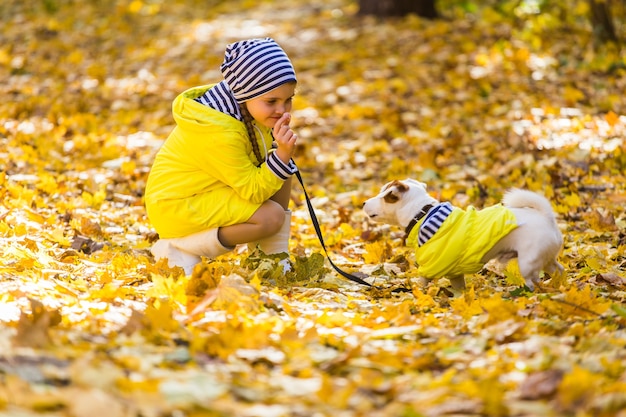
[0,0,626,417]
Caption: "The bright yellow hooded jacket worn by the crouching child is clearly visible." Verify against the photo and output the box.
[144,86,286,238]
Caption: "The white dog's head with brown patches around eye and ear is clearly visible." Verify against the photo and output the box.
[363,179,436,227]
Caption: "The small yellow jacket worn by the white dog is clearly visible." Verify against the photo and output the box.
[407,204,517,278]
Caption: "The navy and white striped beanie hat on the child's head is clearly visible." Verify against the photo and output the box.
[220,38,296,103]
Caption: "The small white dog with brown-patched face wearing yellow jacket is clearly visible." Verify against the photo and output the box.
[363,179,563,291]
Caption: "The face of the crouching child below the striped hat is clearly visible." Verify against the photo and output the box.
[246,83,296,128]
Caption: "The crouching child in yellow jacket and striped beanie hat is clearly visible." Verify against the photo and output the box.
[145,38,297,274]
